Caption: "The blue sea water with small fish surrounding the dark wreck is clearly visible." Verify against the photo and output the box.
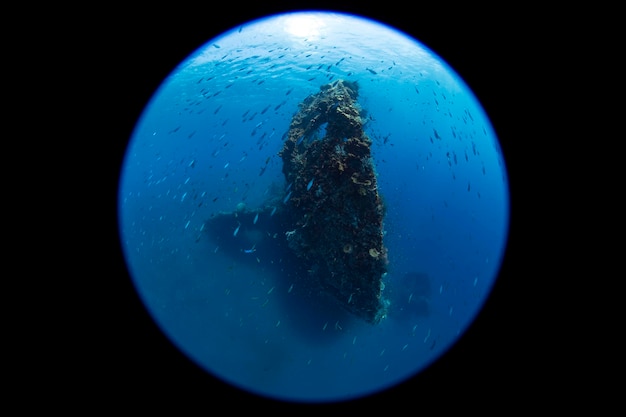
[119,14,509,401]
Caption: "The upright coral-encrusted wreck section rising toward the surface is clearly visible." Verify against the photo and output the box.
[279,80,388,323]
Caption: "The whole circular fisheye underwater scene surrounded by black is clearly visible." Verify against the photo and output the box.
[118,12,509,402]
